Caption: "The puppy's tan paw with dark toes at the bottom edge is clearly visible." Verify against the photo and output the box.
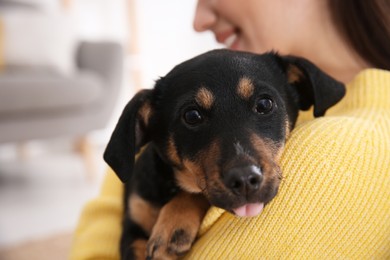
[146,227,197,259]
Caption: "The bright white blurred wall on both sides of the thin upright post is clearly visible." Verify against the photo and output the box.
[71,0,221,89]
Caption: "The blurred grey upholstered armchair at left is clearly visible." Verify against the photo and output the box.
[0,42,123,144]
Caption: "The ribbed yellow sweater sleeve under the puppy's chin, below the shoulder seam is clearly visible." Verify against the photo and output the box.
[186,115,390,259]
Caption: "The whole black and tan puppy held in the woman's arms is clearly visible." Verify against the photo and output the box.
[104,50,345,259]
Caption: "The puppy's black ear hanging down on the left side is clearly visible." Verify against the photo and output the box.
[104,90,153,182]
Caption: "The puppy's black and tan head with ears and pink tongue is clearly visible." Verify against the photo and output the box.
[105,50,345,216]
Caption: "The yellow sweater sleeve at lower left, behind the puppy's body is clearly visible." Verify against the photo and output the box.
[70,169,123,260]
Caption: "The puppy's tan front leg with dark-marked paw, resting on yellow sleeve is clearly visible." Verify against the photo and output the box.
[147,192,210,259]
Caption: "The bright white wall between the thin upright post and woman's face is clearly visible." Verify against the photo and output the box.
[136,0,219,86]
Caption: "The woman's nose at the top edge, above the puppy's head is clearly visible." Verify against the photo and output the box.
[193,0,217,32]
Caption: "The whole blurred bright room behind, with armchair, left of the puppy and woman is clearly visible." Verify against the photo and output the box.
[0,0,221,260]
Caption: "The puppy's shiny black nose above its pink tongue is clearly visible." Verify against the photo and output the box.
[224,165,263,196]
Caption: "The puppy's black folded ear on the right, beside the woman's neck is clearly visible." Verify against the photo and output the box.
[283,56,345,117]
